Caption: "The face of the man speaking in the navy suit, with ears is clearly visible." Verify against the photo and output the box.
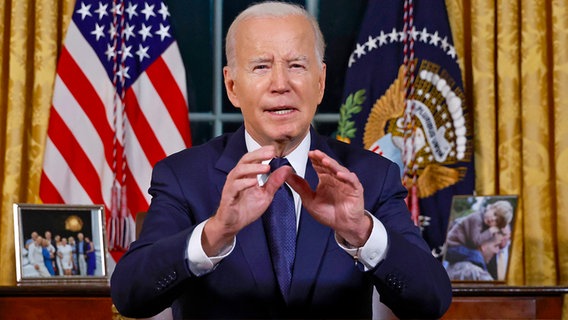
[223,16,325,146]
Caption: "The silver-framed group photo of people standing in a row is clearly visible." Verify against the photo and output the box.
[13,203,109,285]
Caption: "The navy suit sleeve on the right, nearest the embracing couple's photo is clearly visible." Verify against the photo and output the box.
[372,163,452,318]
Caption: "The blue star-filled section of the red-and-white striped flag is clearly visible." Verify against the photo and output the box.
[73,0,174,93]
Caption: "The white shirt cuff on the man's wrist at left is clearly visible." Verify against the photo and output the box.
[187,220,237,277]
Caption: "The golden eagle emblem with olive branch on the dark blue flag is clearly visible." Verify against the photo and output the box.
[338,60,472,198]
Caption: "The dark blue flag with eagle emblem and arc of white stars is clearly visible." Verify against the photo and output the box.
[337,0,474,257]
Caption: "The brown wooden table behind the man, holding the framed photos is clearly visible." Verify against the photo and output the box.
[0,284,568,320]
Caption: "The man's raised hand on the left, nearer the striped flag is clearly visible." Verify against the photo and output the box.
[201,146,293,256]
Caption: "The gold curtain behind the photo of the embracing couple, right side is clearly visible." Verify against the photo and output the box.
[446,0,568,285]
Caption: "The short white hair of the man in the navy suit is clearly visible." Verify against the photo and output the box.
[225,1,325,68]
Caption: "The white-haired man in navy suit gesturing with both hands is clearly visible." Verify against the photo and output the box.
[111,2,451,319]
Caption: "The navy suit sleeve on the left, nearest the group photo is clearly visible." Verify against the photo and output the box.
[111,162,201,318]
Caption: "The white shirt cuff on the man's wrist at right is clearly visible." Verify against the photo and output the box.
[335,210,388,271]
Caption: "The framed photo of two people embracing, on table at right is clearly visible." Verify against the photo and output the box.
[443,195,518,282]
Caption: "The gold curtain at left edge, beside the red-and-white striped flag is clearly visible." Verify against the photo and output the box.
[0,0,75,285]
